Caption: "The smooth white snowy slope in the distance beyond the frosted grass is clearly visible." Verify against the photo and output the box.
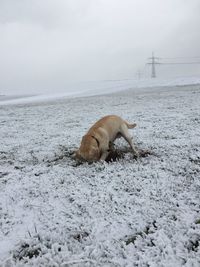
[0,76,200,105]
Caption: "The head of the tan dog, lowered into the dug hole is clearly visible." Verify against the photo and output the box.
[76,135,100,162]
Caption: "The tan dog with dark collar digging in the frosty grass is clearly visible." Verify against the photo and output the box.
[76,115,138,162]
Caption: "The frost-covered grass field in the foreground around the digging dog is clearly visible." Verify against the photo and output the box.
[0,85,200,267]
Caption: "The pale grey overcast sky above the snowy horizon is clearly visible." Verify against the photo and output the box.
[0,0,200,93]
